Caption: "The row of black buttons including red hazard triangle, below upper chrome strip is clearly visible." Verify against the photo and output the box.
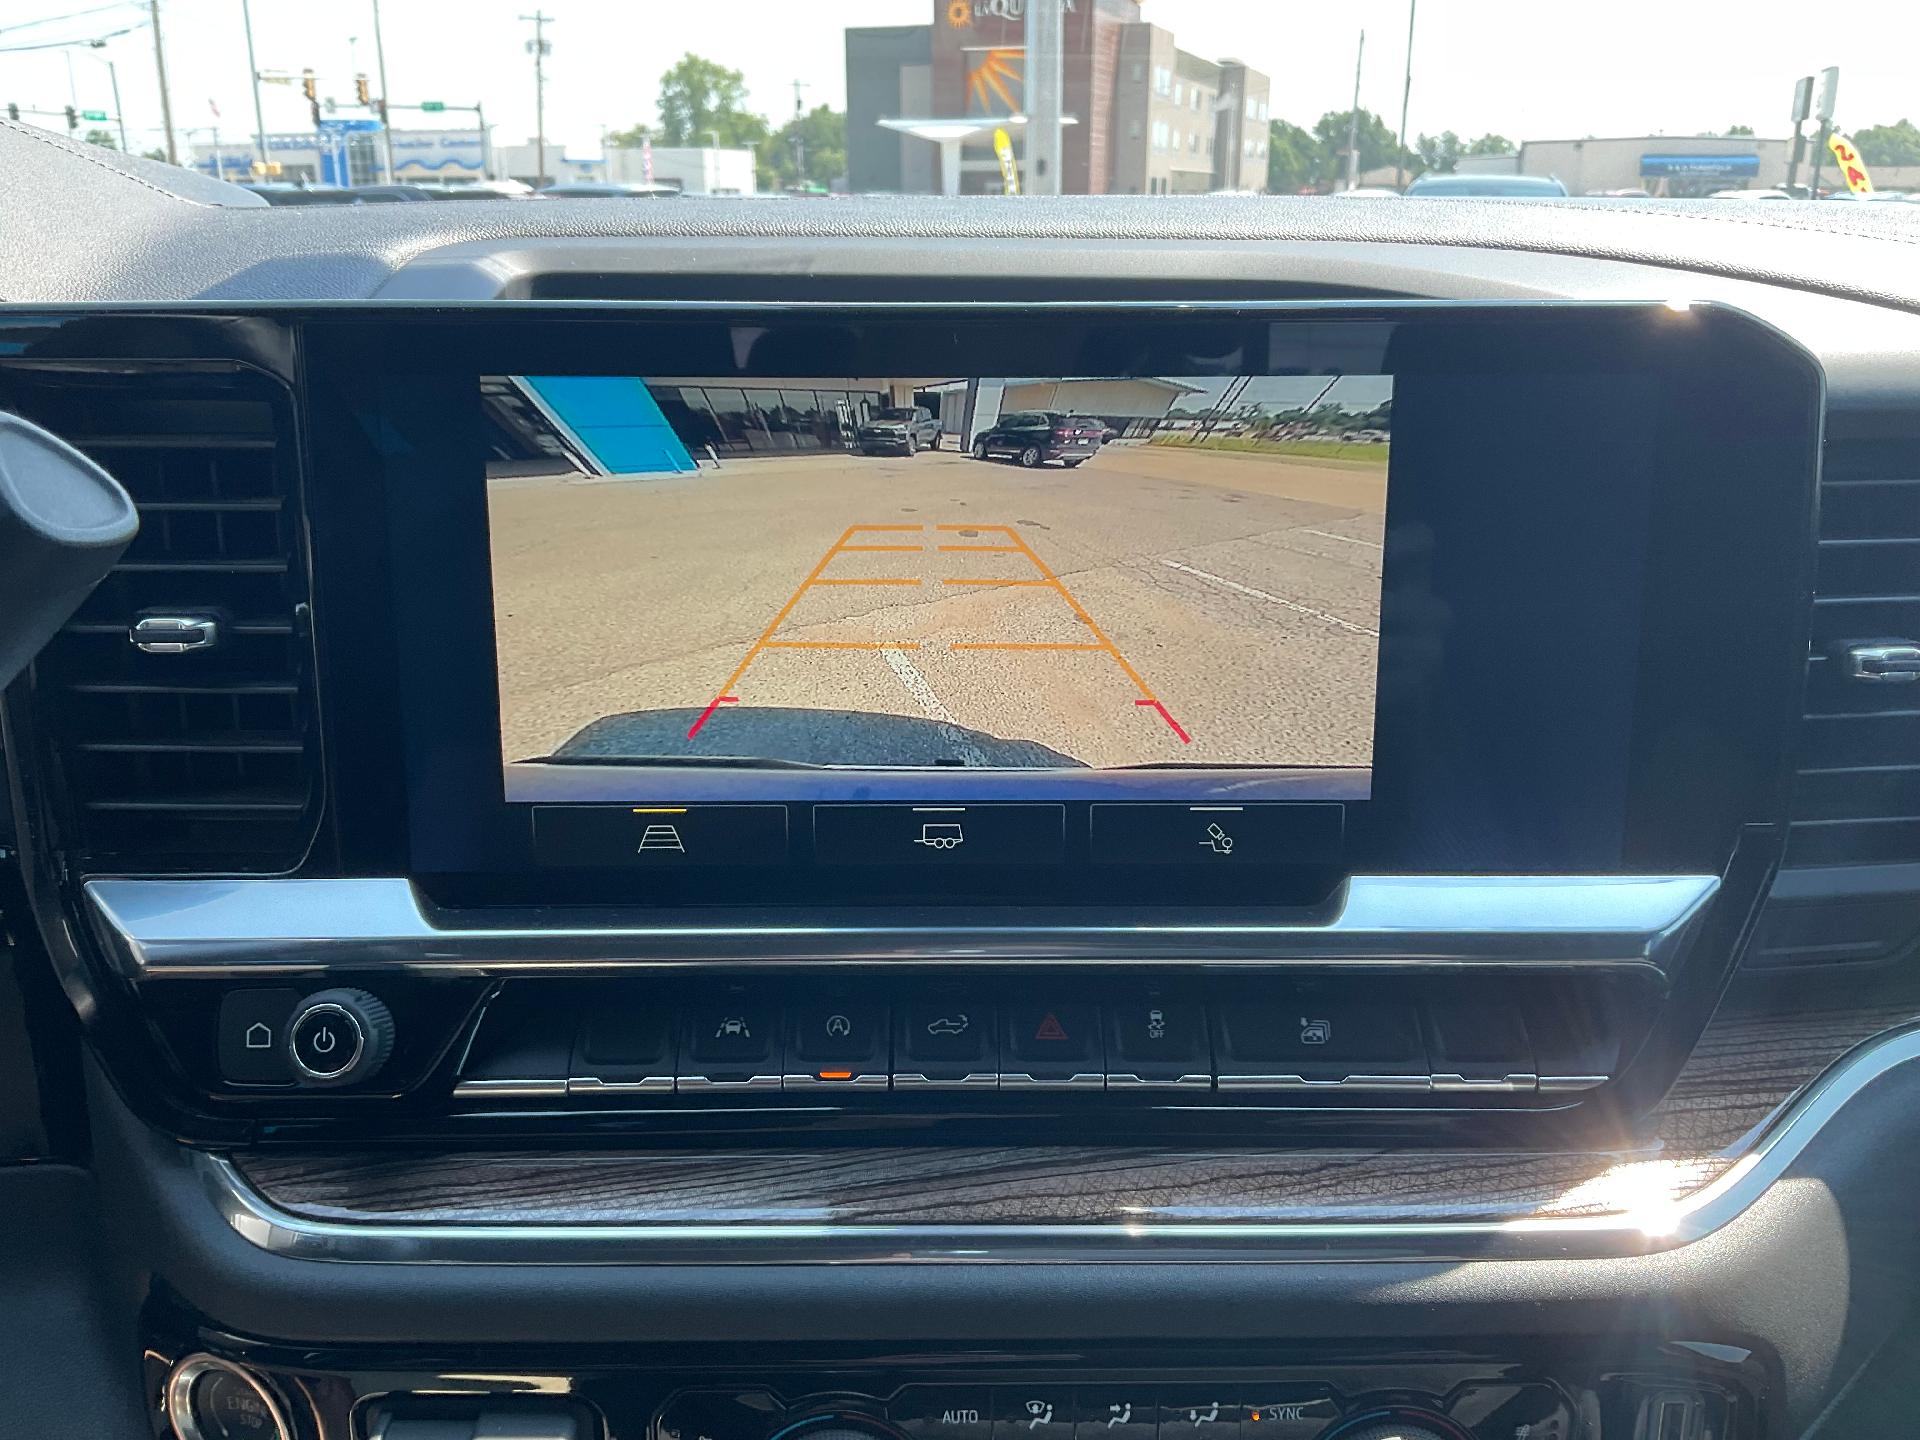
[455,985,1607,1098]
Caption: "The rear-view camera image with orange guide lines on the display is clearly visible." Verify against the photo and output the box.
[480,374,1392,799]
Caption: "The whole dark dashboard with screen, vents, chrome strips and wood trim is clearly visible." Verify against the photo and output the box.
[0,118,1920,1440]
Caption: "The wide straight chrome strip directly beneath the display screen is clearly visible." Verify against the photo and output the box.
[86,876,1718,977]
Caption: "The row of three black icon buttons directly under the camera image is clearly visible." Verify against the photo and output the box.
[534,803,1346,870]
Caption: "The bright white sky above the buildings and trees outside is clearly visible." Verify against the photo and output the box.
[0,0,1920,156]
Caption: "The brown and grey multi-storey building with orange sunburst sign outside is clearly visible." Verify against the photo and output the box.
[847,0,1271,194]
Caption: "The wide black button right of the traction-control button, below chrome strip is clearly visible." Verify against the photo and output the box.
[1213,989,1430,1091]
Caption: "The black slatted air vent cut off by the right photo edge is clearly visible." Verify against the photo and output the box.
[1788,436,1920,866]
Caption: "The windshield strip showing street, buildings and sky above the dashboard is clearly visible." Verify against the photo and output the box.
[0,0,1920,205]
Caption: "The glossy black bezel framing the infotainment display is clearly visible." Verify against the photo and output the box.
[305,301,1820,904]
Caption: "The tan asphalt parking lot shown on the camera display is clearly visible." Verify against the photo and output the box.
[490,444,1386,766]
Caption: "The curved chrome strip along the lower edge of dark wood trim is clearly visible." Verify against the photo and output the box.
[194,1023,1920,1265]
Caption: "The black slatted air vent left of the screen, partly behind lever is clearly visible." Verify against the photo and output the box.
[6,369,319,872]
